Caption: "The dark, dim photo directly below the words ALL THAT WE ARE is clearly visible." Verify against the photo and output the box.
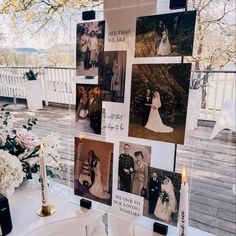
[98,51,127,103]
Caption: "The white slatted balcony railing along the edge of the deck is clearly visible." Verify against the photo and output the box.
[0,67,236,120]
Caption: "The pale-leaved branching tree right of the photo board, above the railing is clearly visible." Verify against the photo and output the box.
[189,0,236,70]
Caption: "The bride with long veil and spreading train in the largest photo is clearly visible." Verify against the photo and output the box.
[145,91,173,133]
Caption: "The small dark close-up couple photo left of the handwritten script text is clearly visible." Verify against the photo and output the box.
[75,84,102,134]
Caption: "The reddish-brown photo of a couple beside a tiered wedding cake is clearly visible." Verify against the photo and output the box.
[74,137,113,205]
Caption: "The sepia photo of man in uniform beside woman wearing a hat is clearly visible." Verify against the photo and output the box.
[118,142,151,197]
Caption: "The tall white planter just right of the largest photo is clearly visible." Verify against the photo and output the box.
[187,89,202,130]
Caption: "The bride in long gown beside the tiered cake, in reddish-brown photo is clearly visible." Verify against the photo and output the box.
[89,160,111,199]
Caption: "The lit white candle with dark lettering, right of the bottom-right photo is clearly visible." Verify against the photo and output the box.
[179,165,189,236]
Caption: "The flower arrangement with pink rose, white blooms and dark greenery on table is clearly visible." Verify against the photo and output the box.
[0,109,63,194]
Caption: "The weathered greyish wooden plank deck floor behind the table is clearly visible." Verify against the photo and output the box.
[4,106,236,236]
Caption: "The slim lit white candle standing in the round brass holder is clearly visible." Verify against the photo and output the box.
[39,144,48,206]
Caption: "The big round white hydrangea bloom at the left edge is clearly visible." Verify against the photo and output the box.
[0,150,25,196]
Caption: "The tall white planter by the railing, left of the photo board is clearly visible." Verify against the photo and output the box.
[25,80,43,110]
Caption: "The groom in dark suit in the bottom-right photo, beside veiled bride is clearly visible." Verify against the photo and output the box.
[148,172,161,215]
